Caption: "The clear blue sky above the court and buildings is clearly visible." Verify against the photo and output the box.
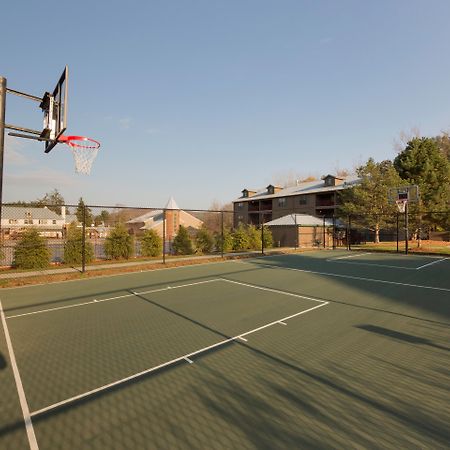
[0,0,450,209]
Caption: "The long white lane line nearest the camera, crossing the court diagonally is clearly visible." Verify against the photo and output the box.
[31,301,329,417]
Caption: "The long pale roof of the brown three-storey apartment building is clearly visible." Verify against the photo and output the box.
[233,175,360,203]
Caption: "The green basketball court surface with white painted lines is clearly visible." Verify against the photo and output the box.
[0,251,450,449]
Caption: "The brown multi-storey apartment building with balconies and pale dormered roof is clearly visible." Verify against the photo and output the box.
[233,175,359,226]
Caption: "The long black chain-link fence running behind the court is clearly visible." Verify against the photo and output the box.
[0,204,450,271]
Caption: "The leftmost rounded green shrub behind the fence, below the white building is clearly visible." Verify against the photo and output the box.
[13,228,50,269]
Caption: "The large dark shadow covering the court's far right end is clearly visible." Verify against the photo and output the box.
[245,255,450,327]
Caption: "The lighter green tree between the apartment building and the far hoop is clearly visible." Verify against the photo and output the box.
[340,158,405,243]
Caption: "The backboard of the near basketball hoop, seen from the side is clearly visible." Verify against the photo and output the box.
[40,66,69,153]
